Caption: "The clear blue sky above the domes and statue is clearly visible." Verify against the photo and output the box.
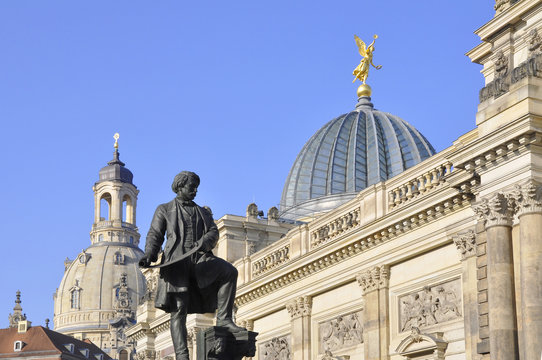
[0,0,494,327]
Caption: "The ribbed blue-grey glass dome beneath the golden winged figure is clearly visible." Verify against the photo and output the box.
[280,96,435,220]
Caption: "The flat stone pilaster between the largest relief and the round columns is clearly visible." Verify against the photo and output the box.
[453,230,478,359]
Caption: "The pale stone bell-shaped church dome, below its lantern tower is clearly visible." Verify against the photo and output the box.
[54,241,146,333]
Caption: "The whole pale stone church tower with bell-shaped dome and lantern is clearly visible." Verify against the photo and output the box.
[54,134,145,360]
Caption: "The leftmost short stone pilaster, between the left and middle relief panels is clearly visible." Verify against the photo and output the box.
[286,296,312,360]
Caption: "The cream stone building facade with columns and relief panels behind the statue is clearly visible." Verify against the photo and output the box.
[128,0,542,360]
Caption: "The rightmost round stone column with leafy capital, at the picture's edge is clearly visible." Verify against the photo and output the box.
[512,180,542,360]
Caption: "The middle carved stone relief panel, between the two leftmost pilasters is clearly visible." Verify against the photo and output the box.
[318,311,363,353]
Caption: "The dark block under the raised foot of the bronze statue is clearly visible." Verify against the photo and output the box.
[197,326,258,360]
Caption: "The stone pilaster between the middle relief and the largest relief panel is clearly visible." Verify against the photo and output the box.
[357,265,390,360]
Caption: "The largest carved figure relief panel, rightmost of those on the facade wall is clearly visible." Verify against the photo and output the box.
[399,279,462,331]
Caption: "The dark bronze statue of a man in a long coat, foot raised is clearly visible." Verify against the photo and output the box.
[140,171,245,360]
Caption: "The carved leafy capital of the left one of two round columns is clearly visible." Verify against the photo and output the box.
[472,192,515,229]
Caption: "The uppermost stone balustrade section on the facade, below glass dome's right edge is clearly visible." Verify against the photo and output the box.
[388,161,452,209]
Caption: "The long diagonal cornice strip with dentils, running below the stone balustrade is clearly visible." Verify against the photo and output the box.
[235,193,472,306]
